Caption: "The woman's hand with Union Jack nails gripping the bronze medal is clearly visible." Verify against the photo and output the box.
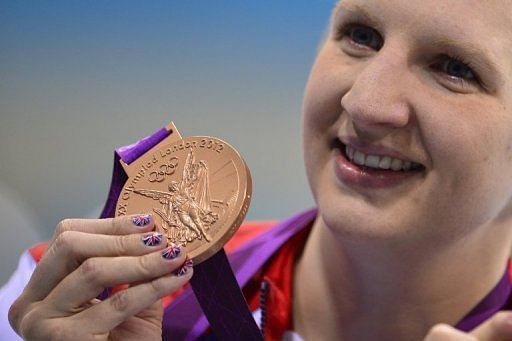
[9,215,192,340]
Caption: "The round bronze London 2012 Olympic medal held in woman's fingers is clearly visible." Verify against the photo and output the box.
[116,123,252,264]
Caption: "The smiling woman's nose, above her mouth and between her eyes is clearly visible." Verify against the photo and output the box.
[341,49,412,138]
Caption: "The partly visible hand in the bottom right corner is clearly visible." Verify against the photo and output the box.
[425,311,512,341]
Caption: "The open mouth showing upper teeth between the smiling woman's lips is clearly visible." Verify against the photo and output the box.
[332,139,425,173]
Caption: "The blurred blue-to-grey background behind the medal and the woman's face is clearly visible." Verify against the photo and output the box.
[0,0,335,286]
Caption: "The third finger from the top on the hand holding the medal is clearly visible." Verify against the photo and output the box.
[45,245,186,312]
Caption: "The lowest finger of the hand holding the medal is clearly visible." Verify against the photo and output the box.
[72,267,193,334]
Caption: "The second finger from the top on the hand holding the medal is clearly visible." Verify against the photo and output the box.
[24,224,163,301]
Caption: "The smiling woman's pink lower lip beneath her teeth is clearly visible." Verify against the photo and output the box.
[334,149,423,188]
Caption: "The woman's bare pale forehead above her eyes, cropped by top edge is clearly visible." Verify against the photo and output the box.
[333,0,512,69]
